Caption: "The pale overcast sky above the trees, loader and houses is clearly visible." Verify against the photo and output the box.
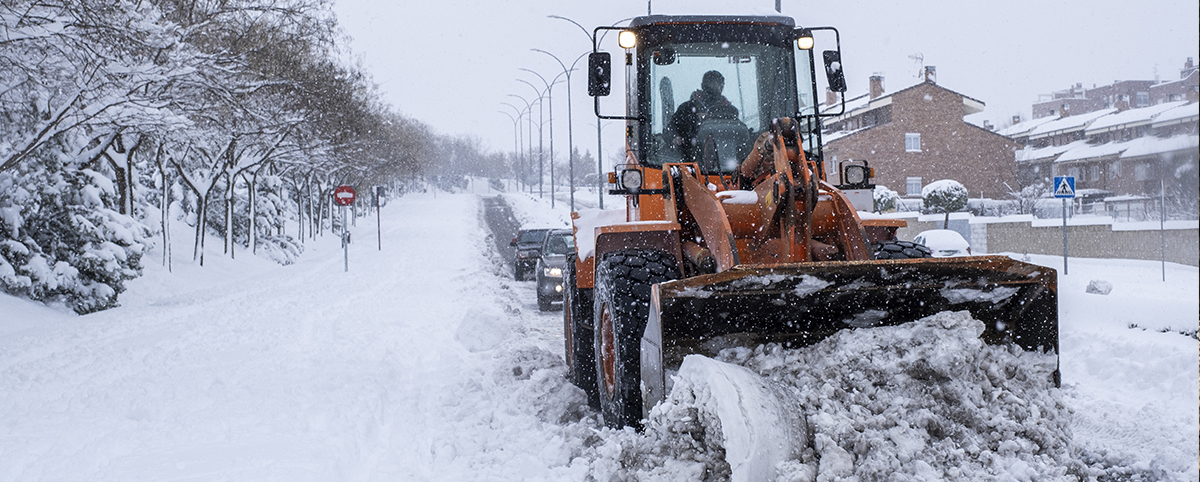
[335,0,1200,158]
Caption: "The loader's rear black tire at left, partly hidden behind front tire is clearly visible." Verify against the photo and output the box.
[563,255,600,410]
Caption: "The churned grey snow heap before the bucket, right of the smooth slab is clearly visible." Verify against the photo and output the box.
[720,312,1087,481]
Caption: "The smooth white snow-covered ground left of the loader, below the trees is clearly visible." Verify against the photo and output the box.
[0,193,584,481]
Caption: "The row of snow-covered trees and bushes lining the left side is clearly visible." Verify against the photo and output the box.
[0,0,504,313]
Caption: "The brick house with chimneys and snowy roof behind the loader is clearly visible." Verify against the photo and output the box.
[823,67,1021,198]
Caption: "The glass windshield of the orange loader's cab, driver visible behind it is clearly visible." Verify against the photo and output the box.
[642,42,815,174]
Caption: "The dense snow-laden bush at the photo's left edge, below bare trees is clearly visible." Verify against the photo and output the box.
[0,155,149,314]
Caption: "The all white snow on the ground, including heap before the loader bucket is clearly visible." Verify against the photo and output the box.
[0,193,1200,481]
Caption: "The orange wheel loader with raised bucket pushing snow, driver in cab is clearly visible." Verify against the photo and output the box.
[563,16,1058,427]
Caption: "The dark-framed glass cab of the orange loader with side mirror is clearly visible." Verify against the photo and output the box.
[589,16,840,178]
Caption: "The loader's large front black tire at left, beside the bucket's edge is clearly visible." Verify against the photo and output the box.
[593,249,678,429]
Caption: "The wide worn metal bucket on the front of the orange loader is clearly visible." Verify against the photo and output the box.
[641,255,1058,409]
